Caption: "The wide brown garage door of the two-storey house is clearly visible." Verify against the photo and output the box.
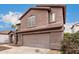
[23,34,49,48]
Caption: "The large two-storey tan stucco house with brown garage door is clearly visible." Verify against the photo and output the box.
[12,5,66,49]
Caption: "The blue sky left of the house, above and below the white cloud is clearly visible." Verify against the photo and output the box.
[0,4,35,31]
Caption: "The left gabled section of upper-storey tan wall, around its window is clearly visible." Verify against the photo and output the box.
[20,10,48,30]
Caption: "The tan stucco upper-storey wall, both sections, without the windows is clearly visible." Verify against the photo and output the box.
[19,8,63,31]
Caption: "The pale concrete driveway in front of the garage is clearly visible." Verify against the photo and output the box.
[0,44,60,54]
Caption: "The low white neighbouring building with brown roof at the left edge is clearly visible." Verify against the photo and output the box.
[0,30,11,43]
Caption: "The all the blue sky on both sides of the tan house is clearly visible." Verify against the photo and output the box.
[0,4,79,30]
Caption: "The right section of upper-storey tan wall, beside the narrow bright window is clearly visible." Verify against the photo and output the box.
[50,8,64,25]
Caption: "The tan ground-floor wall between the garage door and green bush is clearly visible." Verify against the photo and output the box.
[50,31,63,49]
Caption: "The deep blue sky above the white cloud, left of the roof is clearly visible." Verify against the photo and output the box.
[0,4,34,14]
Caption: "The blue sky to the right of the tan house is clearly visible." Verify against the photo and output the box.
[66,4,79,23]
